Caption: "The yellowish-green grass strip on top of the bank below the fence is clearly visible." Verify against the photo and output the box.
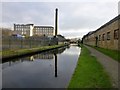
[0,45,64,58]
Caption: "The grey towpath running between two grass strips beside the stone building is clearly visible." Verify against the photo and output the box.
[86,46,120,88]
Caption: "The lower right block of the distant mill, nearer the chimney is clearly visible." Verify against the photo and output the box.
[33,26,54,36]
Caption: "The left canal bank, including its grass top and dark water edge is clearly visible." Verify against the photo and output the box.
[0,44,67,60]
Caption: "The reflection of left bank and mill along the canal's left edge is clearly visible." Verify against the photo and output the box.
[2,47,66,69]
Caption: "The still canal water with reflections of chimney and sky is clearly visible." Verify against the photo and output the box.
[2,46,80,88]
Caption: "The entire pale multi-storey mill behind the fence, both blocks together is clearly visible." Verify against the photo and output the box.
[14,24,54,36]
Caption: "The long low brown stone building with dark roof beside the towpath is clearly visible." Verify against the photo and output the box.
[82,15,120,50]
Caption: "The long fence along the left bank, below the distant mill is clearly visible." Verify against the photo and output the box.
[2,36,57,50]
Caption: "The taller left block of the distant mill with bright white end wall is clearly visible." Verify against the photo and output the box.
[14,24,34,36]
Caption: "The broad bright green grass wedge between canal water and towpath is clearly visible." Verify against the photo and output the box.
[68,46,112,88]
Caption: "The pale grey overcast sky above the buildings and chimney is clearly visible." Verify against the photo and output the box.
[0,0,119,38]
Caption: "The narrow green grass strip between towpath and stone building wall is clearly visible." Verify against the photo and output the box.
[93,47,120,61]
